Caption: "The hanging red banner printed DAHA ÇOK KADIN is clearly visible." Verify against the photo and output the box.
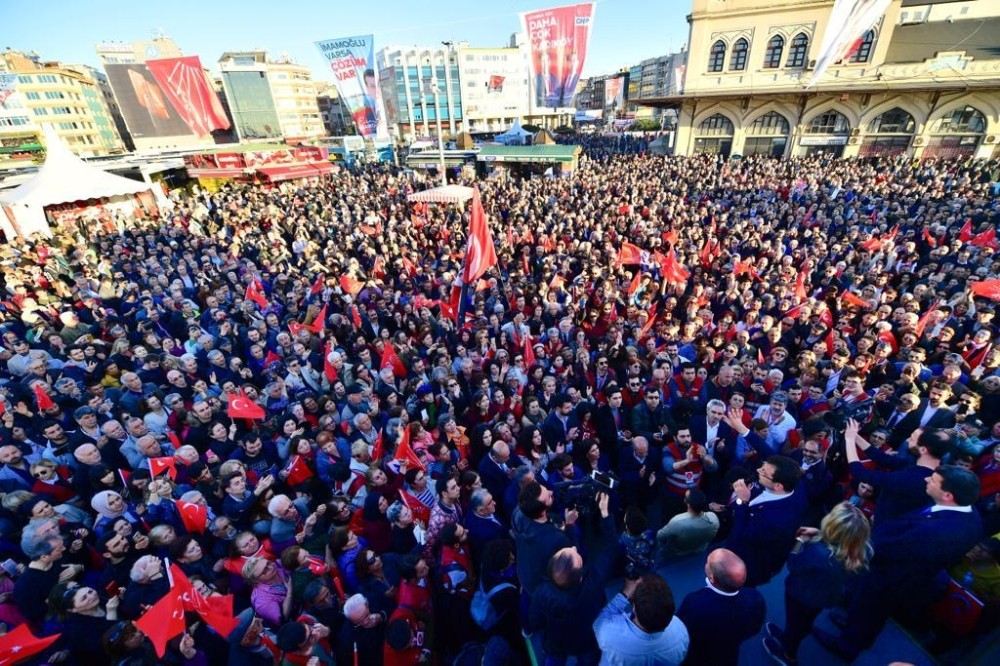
[521,2,594,108]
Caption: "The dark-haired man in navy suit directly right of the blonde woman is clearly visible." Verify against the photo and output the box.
[813,465,983,661]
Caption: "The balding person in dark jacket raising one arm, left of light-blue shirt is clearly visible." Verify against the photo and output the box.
[527,493,615,664]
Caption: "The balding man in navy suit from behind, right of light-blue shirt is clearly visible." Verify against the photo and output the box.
[677,548,767,666]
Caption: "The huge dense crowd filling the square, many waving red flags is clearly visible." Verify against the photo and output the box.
[0,143,1000,666]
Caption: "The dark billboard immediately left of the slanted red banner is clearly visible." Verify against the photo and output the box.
[104,63,194,139]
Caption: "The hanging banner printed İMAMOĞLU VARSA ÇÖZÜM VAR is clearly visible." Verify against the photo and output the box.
[316,35,389,138]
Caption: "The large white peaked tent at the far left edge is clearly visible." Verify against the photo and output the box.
[0,125,152,238]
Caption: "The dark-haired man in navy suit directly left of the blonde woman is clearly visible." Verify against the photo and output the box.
[723,456,805,587]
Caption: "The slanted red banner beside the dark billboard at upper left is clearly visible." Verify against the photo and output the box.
[146,56,229,136]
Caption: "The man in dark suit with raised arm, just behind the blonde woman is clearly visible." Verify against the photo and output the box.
[844,421,952,530]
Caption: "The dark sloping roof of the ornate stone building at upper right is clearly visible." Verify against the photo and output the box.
[885,17,1000,63]
